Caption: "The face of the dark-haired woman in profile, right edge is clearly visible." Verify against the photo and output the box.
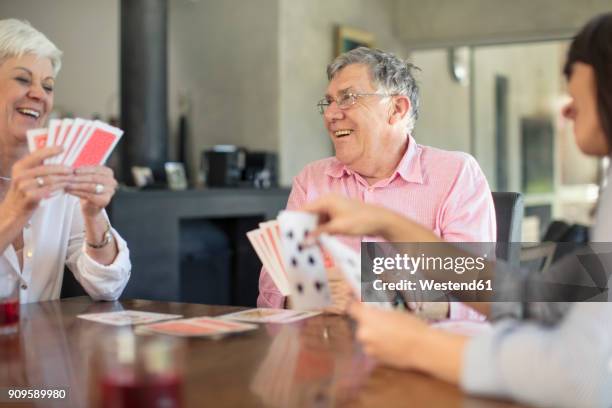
[563,62,609,156]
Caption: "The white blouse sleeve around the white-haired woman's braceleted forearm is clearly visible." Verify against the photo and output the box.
[66,202,132,300]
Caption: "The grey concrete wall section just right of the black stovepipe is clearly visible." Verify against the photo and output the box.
[169,0,280,180]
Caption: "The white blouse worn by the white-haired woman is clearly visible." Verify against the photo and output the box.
[0,194,132,303]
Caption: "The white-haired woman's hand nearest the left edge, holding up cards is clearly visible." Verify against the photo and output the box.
[1,146,72,223]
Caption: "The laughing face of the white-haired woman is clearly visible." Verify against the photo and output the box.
[0,54,55,142]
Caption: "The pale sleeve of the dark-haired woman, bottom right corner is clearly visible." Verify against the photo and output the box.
[461,302,612,407]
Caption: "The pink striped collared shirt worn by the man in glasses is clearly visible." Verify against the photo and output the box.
[257,136,496,320]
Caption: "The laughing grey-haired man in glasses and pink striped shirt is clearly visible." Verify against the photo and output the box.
[257,47,496,318]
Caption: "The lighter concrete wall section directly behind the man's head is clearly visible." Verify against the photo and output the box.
[279,0,407,184]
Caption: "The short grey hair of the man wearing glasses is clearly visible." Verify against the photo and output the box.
[327,47,419,133]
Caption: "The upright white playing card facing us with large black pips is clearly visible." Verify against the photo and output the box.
[278,211,331,310]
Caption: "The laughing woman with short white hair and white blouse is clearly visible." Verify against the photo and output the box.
[0,19,131,303]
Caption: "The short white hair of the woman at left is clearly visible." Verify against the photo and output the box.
[0,18,62,75]
